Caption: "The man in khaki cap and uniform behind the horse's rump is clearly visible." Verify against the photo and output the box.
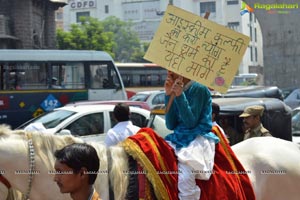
[240,105,272,140]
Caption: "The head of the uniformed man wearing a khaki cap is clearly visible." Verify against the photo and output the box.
[240,106,264,129]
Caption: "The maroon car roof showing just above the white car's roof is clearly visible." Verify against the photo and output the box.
[65,100,151,110]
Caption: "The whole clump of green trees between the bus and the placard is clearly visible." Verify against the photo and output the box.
[57,16,149,62]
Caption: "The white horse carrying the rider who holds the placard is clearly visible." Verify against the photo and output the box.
[0,127,300,200]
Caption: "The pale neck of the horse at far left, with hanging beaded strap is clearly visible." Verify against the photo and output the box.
[0,126,82,199]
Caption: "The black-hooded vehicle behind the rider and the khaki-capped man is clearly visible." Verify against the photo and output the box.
[147,97,292,145]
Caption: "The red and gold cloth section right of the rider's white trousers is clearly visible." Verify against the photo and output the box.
[196,126,255,200]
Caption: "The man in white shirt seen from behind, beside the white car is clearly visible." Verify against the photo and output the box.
[104,103,140,147]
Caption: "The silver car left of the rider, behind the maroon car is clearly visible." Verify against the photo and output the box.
[129,90,165,109]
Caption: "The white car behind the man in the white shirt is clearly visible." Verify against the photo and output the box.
[17,105,169,142]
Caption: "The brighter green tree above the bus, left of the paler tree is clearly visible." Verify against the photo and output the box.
[56,17,116,58]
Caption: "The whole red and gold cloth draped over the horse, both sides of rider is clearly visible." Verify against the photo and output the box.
[122,127,255,200]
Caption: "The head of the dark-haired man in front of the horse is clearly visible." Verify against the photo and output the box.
[54,143,99,193]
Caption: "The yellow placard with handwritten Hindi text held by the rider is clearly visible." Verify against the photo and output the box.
[144,5,250,93]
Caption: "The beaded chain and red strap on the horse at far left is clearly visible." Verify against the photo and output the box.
[0,134,35,200]
